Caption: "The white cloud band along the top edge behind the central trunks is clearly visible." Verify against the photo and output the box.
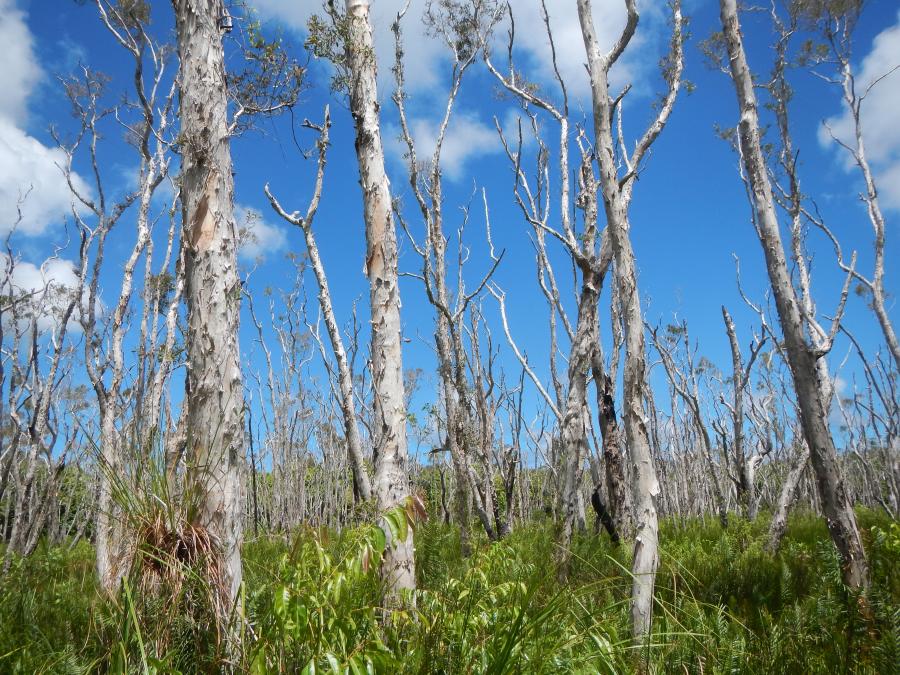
[253,0,665,97]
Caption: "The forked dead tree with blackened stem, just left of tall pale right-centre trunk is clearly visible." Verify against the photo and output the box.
[485,3,625,556]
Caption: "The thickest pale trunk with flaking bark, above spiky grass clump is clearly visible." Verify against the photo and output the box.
[173,0,244,609]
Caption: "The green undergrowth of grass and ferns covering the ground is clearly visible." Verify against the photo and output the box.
[0,510,900,674]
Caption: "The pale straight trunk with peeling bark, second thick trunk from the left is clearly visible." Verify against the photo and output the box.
[346,0,416,594]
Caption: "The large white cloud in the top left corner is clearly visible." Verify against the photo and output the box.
[0,0,88,235]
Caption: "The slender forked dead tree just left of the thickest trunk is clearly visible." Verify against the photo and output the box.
[75,0,175,593]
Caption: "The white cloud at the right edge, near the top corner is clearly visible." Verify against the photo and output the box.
[819,13,900,210]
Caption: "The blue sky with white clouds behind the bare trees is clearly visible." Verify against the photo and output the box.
[0,0,900,460]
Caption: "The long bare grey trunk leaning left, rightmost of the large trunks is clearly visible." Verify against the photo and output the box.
[720,0,869,589]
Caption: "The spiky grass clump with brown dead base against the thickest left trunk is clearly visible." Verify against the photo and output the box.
[98,436,234,670]
